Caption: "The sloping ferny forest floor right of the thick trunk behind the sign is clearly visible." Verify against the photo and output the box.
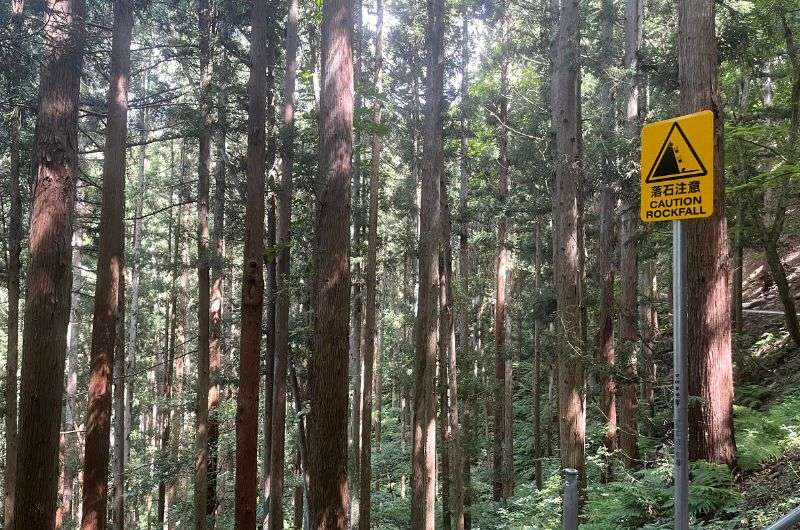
[735,237,800,528]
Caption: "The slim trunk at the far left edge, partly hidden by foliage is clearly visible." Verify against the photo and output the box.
[3,0,25,528]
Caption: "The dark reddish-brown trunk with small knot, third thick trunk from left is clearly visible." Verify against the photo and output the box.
[234,0,271,528]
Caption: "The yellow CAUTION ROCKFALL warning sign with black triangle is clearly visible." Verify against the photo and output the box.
[639,110,714,222]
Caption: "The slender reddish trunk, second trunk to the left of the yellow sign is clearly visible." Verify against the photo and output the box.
[597,0,617,480]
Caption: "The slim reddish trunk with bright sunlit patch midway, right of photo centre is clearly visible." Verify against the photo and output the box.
[492,0,513,501]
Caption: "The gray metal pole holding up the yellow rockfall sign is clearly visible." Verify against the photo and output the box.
[672,221,689,530]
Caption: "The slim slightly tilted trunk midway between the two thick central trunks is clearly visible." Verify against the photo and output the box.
[358,0,383,530]
